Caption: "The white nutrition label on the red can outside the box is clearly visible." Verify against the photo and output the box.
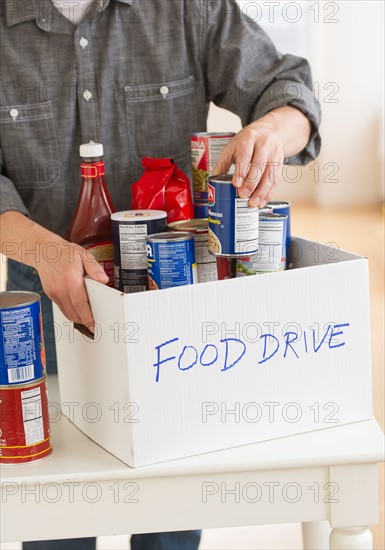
[20,388,44,445]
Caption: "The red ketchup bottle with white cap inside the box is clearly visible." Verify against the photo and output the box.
[67,141,116,287]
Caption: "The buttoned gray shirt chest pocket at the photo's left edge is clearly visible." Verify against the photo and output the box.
[0,102,61,189]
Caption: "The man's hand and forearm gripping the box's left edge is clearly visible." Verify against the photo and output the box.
[0,211,108,332]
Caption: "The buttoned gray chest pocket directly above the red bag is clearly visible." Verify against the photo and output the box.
[124,76,195,162]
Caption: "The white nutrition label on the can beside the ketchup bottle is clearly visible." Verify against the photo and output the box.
[119,223,147,269]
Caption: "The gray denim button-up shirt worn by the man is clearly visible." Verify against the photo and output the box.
[0,0,320,235]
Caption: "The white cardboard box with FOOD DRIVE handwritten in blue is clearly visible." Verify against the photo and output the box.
[54,238,372,467]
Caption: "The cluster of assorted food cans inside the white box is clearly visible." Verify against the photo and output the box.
[111,132,290,293]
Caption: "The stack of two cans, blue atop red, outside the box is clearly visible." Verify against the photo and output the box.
[0,292,52,464]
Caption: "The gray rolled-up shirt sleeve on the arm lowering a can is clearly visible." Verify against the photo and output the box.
[204,0,321,164]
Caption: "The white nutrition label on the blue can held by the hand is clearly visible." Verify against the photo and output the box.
[235,198,259,254]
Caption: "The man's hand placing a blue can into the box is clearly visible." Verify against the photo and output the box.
[213,106,311,208]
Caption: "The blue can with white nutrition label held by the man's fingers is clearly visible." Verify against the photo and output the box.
[208,175,259,256]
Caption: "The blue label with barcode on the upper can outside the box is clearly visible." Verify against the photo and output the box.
[1,307,36,383]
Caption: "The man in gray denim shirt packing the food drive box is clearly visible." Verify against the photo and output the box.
[0,0,320,550]
